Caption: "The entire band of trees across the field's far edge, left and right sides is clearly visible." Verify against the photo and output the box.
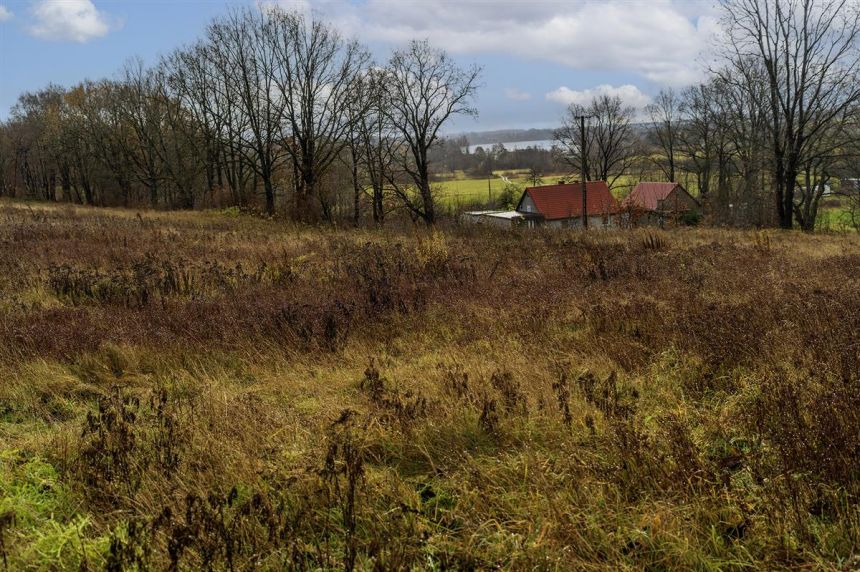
[0,0,860,230]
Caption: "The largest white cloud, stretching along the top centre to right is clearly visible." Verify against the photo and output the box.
[314,0,716,86]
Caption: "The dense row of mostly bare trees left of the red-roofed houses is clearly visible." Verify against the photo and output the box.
[0,8,480,224]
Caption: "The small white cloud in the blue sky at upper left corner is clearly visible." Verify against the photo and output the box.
[30,0,113,43]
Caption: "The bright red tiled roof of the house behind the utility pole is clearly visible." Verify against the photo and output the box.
[517,181,618,220]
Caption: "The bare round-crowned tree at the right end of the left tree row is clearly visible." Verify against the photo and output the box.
[383,40,481,224]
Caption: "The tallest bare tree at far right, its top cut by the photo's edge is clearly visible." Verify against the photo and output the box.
[722,0,860,228]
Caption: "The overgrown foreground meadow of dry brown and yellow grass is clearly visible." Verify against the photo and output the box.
[0,202,860,570]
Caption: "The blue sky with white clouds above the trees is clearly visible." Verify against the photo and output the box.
[0,0,719,132]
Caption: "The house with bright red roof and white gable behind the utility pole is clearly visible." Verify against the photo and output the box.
[516,181,619,228]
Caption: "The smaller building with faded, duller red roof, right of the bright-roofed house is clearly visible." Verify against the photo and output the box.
[621,183,699,226]
